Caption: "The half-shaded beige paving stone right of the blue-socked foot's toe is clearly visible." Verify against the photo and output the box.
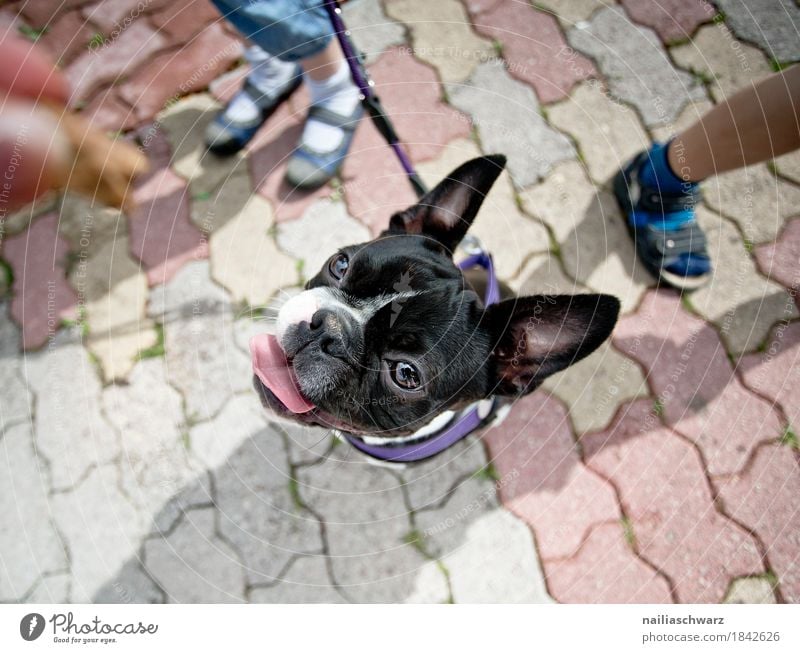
[689,206,798,354]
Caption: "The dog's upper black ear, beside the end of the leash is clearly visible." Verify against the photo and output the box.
[386,154,506,253]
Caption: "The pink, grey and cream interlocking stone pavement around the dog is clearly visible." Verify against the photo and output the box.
[0,0,800,603]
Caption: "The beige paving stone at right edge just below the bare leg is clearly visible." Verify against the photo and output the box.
[703,164,800,244]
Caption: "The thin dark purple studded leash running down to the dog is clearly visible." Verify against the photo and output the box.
[323,0,428,197]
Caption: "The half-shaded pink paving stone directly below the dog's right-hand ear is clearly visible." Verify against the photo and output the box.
[484,392,621,560]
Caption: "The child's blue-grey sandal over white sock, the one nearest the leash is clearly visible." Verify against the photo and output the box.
[286,103,364,190]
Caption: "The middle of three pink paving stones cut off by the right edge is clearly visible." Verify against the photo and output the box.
[739,322,800,431]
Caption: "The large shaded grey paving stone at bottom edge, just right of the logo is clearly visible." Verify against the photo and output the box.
[144,508,245,603]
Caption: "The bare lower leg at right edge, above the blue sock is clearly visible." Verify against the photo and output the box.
[667,65,800,181]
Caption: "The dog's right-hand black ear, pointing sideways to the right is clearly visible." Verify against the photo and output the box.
[485,295,619,396]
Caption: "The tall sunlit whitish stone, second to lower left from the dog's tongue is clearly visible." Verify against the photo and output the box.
[103,358,200,522]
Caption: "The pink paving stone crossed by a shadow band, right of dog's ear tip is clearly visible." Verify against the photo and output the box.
[613,291,781,475]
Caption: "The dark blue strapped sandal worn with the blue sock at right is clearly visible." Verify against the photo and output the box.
[614,151,712,290]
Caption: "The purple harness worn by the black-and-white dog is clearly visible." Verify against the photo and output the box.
[342,249,500,463]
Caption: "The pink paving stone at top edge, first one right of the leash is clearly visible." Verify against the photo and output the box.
[473,2,597,104]
